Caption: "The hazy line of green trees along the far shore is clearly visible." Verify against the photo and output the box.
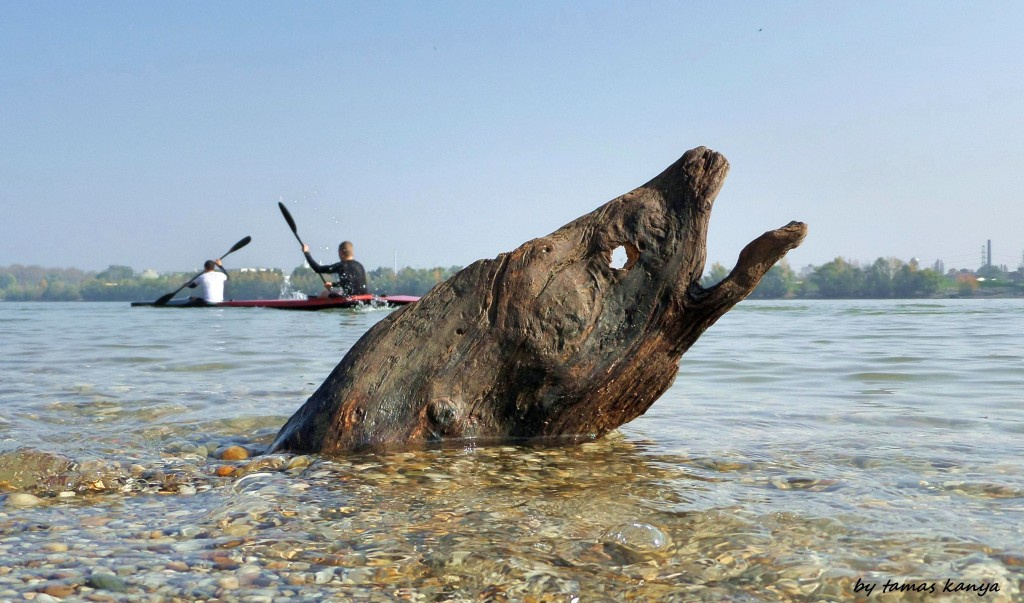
[0,257,1024,301]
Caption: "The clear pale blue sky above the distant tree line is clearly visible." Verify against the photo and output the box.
[0,0,1024,271]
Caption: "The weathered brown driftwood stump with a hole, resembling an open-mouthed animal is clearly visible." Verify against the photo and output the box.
[270,147,807,454]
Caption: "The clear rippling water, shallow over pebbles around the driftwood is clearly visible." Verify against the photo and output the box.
[0,300,1024,601]
